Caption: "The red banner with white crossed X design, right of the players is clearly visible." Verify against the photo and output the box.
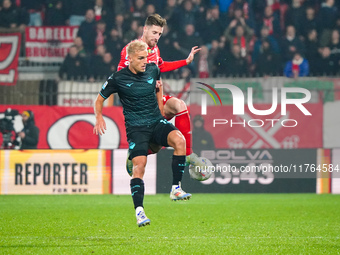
[190,103,323,150]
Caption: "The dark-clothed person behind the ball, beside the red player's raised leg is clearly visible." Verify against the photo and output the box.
[192,115,215,155]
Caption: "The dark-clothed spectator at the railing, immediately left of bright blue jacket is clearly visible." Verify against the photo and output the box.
[255,39,281,76]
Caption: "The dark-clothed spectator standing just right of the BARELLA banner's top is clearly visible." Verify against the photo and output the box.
[77,9,97,53]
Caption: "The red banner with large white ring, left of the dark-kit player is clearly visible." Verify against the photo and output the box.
[0,105,128,149]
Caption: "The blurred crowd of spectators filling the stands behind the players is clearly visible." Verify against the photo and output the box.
[0,0,340,80]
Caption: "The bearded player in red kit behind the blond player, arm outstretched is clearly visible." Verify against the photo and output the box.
[118,14,205,175]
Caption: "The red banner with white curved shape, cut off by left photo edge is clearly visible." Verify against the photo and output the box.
[0,33,21,85]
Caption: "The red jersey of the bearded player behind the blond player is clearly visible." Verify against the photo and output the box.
[117,40,187,72]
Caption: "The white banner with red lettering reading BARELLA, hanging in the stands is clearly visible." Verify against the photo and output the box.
[26,26,78,62]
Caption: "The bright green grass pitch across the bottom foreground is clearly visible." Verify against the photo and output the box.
[0,194,340,254]
